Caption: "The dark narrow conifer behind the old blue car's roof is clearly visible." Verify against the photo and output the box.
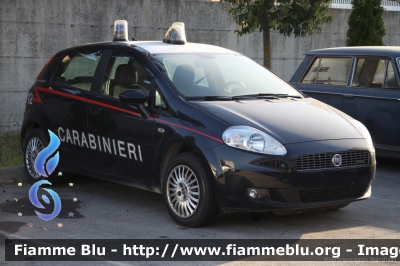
[346,0,386,46]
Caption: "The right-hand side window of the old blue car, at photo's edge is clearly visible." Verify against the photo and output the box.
[352,58,398,89]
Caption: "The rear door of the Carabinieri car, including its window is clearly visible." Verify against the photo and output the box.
[47,48,103,168]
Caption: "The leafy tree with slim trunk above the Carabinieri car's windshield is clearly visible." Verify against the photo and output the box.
[221,0,332,68]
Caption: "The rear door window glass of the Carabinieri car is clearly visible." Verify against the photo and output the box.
[55,51,101,90]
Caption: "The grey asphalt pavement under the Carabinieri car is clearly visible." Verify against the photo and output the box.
[0,155,400,265]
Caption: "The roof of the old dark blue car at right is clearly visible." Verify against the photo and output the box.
[306,46,400,57]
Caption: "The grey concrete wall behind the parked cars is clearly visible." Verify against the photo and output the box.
[0,0,400,134]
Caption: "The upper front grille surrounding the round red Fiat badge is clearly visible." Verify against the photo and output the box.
[296,151,370,171]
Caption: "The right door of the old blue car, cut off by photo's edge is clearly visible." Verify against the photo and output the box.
[343,56,400,150]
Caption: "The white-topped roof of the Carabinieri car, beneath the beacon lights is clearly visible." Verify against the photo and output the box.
[74,41,239,54]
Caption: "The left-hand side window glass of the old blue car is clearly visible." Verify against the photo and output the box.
[300,57,351,86]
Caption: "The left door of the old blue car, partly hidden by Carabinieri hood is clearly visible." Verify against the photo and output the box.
[295,56,352,110]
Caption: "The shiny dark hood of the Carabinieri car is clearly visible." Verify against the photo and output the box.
[191,98,365,144]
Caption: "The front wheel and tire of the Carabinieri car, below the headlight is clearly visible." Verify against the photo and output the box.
[163,153,220,227]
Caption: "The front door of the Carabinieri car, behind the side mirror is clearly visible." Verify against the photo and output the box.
[88,49,154,187]
